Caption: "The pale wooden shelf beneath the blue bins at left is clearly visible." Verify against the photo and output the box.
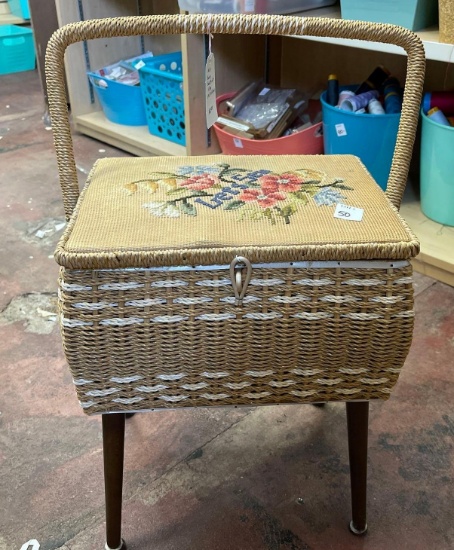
[75,111,186,156]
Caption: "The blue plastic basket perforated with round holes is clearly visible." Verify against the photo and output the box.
[139,52,186,145]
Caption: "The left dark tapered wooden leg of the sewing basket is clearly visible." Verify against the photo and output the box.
[102,413,125,550]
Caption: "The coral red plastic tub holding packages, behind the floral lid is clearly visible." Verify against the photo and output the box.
[214,93,323,155]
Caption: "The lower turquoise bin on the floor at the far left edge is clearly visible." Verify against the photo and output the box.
[0,25,35,74]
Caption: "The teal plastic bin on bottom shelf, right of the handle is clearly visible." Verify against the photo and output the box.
[420,111,454,226]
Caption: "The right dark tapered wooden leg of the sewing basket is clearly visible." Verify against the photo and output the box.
[346,401,369,535]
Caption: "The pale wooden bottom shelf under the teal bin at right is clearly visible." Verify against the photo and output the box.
[401,189,454,286]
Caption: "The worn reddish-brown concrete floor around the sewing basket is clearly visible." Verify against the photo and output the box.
[0,72,454,550]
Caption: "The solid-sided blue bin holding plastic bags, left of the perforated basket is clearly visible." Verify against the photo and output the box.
[87,73,147,126]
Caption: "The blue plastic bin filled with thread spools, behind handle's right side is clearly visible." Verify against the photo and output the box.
[321,86,400,189]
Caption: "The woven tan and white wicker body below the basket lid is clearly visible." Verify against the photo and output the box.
[60,262,414,414]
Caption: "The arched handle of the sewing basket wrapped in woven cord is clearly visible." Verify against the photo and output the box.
[46,15,425,218]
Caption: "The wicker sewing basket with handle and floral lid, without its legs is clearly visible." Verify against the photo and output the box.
[47,15,424,414]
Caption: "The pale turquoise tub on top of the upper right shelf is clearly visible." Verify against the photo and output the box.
[341,0,438,31]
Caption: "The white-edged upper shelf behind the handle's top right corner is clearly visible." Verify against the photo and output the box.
[295,6,454,62]
